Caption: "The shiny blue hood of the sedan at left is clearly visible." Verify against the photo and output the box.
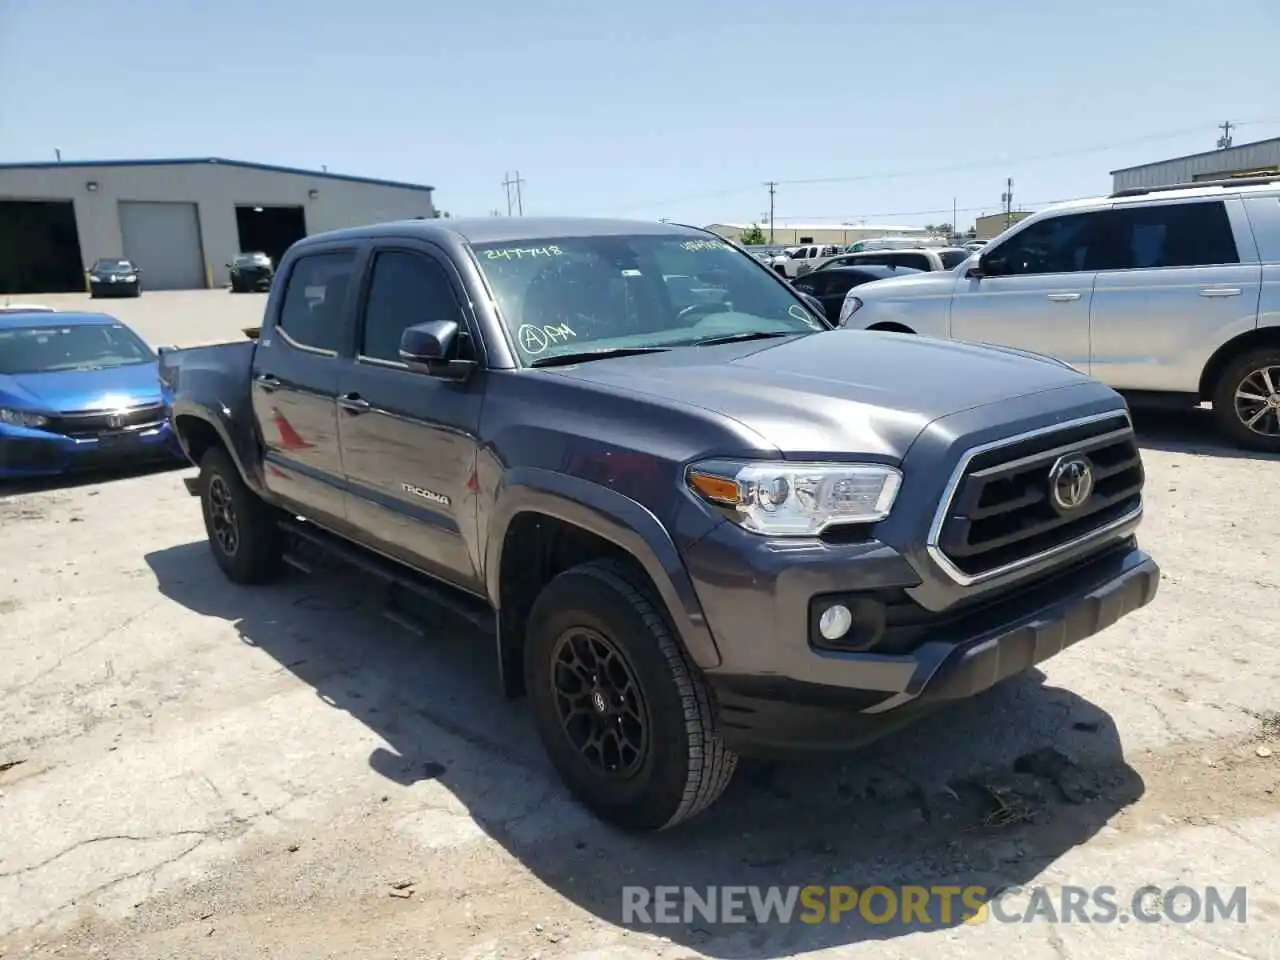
[0,361,160,413]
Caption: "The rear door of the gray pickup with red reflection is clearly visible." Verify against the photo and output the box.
[252,239,357,525]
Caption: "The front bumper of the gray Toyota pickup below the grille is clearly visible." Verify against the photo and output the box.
[707,538,1160,756]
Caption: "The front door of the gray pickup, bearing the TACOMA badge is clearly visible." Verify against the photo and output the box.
[338,241,483,593]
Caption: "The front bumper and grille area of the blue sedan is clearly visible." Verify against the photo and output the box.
[0,421,183,480]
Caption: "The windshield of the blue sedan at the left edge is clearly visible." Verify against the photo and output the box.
[0,324,155,375]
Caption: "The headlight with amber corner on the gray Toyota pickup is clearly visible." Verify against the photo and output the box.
[686,461,902,536]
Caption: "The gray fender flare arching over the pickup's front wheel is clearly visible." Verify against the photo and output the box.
[484,467,721,669]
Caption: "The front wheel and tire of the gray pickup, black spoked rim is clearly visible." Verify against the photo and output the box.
[525,561,737,831]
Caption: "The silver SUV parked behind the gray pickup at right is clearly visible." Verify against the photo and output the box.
[840,177,1280,452]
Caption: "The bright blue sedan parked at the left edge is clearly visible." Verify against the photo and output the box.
[0,311,182,479]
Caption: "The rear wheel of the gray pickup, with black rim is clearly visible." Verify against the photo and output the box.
[200,447,283,584]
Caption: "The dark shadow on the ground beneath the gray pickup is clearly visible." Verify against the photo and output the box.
[146,541,1144,960]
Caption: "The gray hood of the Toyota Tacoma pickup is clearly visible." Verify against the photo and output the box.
[547,330,1088,460]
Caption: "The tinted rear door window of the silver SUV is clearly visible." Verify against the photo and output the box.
[1108,201,1240,270]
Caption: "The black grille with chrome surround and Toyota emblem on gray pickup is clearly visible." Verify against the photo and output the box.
[929,412,1146,582]
